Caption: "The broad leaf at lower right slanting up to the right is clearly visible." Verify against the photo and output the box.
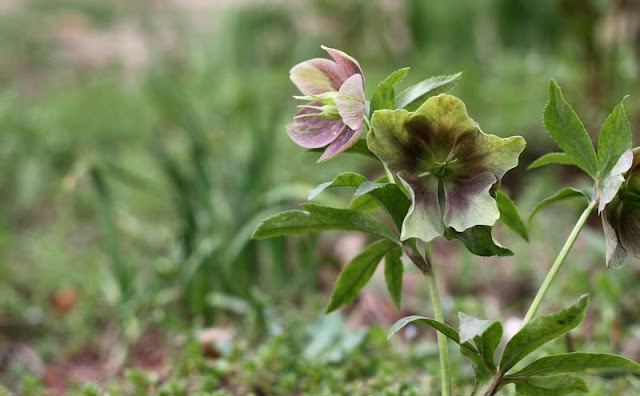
[500,294,589,373]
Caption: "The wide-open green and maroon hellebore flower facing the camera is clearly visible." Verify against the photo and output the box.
[367,94,525,241]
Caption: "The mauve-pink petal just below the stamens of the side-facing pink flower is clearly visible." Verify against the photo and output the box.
[287,102,348,148]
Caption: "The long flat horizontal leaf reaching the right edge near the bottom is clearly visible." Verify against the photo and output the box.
[510,352,640,377]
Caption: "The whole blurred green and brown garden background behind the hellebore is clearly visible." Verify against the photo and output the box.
[0,0,640,395]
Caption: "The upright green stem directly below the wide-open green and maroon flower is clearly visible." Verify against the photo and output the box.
[404,243,451,396]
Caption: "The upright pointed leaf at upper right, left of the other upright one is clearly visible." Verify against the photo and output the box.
[543,79,598,178]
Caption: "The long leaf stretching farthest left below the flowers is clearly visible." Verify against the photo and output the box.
[251,204,398,242]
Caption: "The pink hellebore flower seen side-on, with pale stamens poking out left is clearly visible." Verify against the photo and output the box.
[287,46,365,162]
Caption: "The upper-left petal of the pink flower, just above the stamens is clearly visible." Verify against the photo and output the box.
[289,58,346,95]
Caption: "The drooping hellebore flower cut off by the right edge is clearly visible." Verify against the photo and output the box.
[601,147,640,268]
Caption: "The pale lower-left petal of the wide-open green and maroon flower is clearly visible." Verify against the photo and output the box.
[398,174,444,242]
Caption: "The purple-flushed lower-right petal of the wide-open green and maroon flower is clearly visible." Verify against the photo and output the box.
[443,172,500,232]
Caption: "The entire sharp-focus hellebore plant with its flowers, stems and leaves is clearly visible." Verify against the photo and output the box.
[253,47,640,396]
